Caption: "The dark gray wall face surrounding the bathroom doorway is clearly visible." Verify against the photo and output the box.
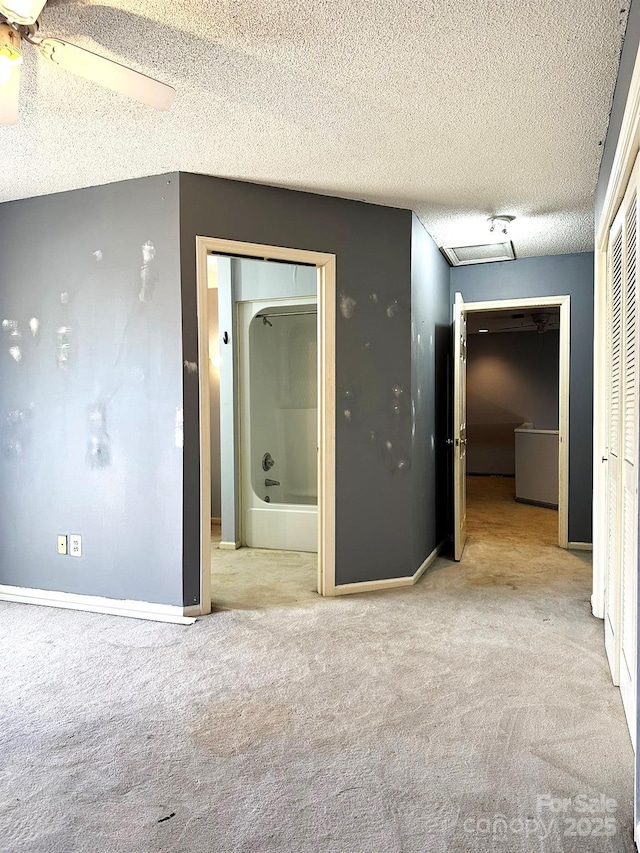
[180,174,447,588]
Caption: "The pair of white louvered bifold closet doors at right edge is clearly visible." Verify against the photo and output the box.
[605,153,640,748]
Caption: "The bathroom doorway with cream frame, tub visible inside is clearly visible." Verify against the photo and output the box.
[197,237,335,602]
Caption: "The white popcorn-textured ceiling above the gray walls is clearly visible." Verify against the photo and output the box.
[0,0,627,257]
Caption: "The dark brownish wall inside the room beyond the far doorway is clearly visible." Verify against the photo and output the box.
[467,331,560,475]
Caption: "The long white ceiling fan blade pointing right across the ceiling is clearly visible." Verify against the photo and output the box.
[37,38,176,110]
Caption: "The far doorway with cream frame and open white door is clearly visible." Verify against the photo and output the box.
[452,293,570,560]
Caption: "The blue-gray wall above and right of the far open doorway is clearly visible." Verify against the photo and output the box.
[451,252,593,542]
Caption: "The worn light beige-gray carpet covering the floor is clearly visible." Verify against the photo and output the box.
[0,538,634,853]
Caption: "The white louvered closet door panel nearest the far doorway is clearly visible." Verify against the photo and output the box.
[604,211,623,684]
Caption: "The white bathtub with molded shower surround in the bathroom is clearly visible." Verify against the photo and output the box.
[239,297,318,552]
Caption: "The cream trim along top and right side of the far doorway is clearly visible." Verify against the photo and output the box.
[464,296,571,548]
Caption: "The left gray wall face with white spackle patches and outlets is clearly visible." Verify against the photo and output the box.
[0,175,183,605]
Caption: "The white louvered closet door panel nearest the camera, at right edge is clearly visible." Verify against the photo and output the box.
[618,167,639,747]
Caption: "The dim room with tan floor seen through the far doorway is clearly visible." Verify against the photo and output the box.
[466,307,560,545]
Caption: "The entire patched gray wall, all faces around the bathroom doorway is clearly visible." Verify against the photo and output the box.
[0,168,449,606]
